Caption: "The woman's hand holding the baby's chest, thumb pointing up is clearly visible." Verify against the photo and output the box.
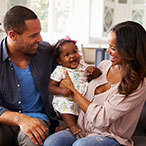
[60,71,74,91]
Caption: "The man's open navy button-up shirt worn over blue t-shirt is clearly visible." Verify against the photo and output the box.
[0,38,56,122]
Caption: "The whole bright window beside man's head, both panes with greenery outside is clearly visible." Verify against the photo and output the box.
[30,0,72,42]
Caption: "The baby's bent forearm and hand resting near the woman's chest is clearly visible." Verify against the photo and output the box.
[85,66,102,81]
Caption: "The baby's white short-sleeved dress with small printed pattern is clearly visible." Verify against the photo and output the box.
[51,60,88,115]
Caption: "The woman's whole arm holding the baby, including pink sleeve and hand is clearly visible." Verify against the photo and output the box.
[61,73,146,127]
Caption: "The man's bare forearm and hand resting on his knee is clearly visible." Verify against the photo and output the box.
[0,111,48,145]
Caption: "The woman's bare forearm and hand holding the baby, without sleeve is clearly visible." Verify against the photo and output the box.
[60,72,90,112]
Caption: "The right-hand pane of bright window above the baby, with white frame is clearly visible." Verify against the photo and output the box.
[48,0,73,42]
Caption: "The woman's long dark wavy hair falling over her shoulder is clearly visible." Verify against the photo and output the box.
[111,21,146,96]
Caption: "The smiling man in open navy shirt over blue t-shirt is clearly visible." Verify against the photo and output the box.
[0,6,57,146]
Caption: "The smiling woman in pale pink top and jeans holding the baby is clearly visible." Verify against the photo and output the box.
[44,21,146,146]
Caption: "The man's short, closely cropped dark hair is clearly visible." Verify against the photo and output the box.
[3,6,37,34]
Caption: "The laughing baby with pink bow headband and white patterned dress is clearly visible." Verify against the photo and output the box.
[48,36,101,135]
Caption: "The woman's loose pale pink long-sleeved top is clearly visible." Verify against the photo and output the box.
[78,60,146,146]
